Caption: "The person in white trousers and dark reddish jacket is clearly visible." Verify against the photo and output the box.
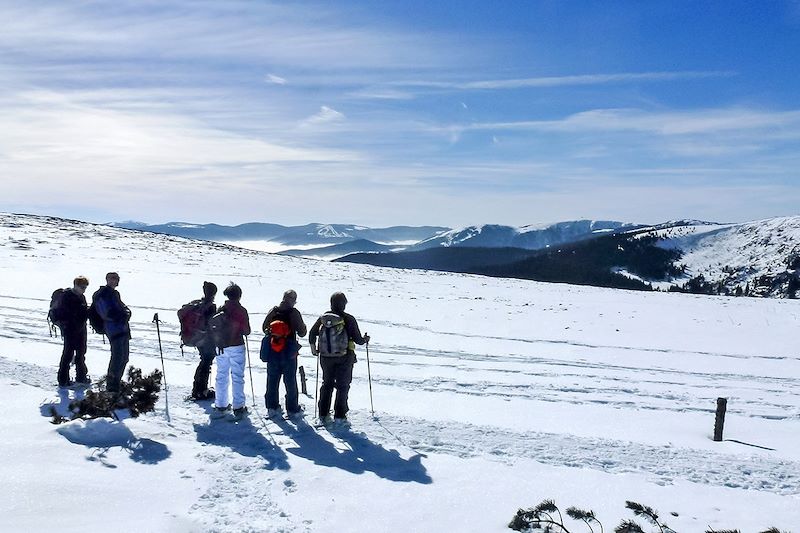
[209,282,250,418]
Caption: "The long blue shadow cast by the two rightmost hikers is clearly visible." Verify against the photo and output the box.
[276,420,433,485]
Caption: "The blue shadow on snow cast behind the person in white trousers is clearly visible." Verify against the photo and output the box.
[194,405,289,470]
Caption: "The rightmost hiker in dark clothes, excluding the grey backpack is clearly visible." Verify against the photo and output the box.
[308,292,369,422]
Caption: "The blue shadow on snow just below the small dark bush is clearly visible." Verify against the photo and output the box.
[56,418,172,468]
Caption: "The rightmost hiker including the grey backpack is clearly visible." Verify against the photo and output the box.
[308,292,369,422]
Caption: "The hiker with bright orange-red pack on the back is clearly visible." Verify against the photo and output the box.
[261,289,307,418]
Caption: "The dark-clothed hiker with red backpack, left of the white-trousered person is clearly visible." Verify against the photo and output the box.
[178,281,217,401]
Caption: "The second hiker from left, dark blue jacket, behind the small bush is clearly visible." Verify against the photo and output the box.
[92,272,131,392]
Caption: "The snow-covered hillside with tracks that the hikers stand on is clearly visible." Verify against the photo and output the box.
[0,214,800,533]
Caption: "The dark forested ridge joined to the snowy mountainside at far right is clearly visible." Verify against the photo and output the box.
[337,217,800,298]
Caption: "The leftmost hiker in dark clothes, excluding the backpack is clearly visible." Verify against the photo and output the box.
[58,276,92,387]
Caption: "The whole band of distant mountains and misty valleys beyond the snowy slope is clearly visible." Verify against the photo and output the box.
[112,217,800,297]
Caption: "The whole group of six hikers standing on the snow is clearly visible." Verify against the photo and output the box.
[48,272,370,423]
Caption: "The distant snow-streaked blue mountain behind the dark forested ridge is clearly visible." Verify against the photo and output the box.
[408,220,640,250]
